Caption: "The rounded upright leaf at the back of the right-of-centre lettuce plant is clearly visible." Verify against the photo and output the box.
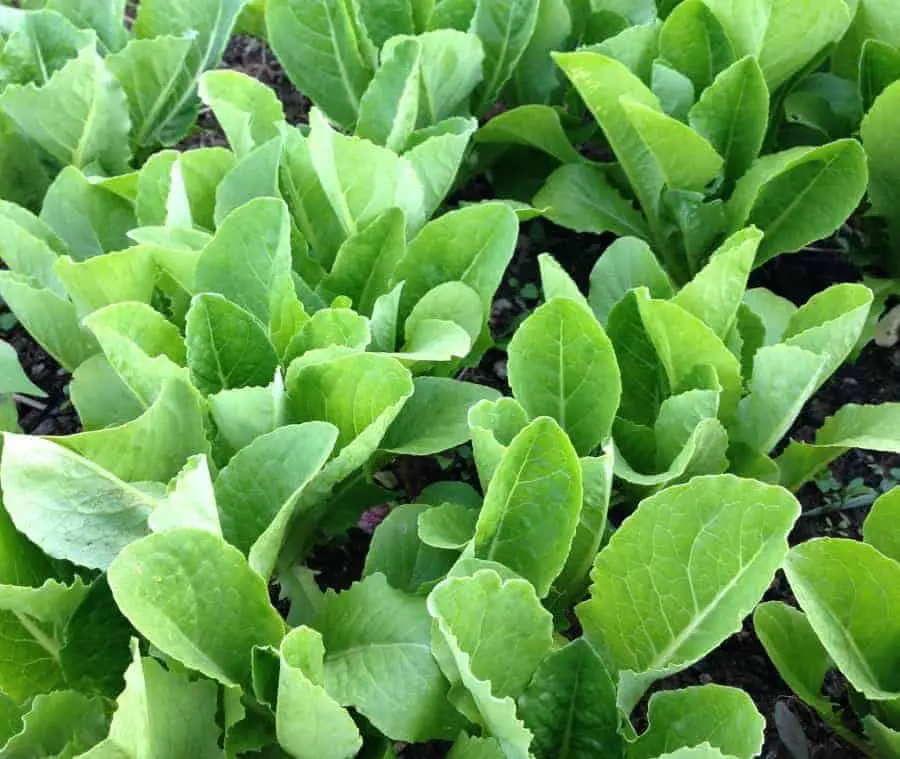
[588,237,674,326]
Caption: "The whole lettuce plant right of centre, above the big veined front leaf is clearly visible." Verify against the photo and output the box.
[492,228,900,493]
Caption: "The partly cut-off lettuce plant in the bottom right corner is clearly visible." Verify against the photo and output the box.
[754,490,900,759]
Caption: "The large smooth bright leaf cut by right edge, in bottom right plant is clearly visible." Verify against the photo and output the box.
[784,538,900,700]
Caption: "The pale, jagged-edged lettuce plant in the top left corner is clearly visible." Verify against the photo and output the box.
[0,0,245,210]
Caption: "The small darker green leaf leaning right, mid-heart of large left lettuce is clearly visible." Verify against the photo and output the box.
[317,208,406,316]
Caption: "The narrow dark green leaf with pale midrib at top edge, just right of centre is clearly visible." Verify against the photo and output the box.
[469,0,540,114]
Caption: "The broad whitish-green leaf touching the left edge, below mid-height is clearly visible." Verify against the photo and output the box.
[0,433,156,569]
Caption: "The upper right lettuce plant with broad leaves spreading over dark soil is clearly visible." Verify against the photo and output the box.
[478,0,867,284]
